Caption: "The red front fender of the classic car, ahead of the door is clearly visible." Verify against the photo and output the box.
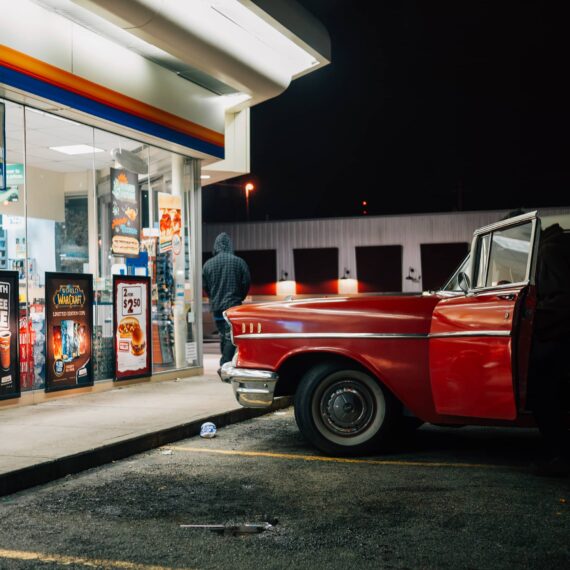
[228,295,439,419]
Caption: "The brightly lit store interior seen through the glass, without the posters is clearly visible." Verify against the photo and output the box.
[0,99,198,391]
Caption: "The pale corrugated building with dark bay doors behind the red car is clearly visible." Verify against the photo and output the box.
[203,208,570,302]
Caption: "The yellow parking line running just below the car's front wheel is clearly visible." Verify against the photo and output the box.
[161,445,502,469]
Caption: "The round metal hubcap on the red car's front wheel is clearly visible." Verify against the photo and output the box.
[320,379,375,436]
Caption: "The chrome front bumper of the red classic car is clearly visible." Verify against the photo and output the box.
[220,362,279,408]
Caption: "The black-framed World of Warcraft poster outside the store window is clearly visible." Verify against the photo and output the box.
[45,273,93,392]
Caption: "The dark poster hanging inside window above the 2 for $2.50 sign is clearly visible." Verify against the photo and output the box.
[111,168,141,257]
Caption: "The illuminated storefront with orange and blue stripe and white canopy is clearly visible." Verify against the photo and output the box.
[0,0,328,401]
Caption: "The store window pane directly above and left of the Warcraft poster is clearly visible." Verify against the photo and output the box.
[20,107,95,388]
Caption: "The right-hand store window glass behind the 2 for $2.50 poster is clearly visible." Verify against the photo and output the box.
[94,130,198,372]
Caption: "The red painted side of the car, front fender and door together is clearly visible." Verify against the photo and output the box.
[227,288,528,425]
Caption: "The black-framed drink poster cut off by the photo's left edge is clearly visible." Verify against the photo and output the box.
[0,271,20,394]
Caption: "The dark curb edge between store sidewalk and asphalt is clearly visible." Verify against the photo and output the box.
[0,396,293,497]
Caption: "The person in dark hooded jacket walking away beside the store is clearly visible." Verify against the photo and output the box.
[202,232,251,366]
